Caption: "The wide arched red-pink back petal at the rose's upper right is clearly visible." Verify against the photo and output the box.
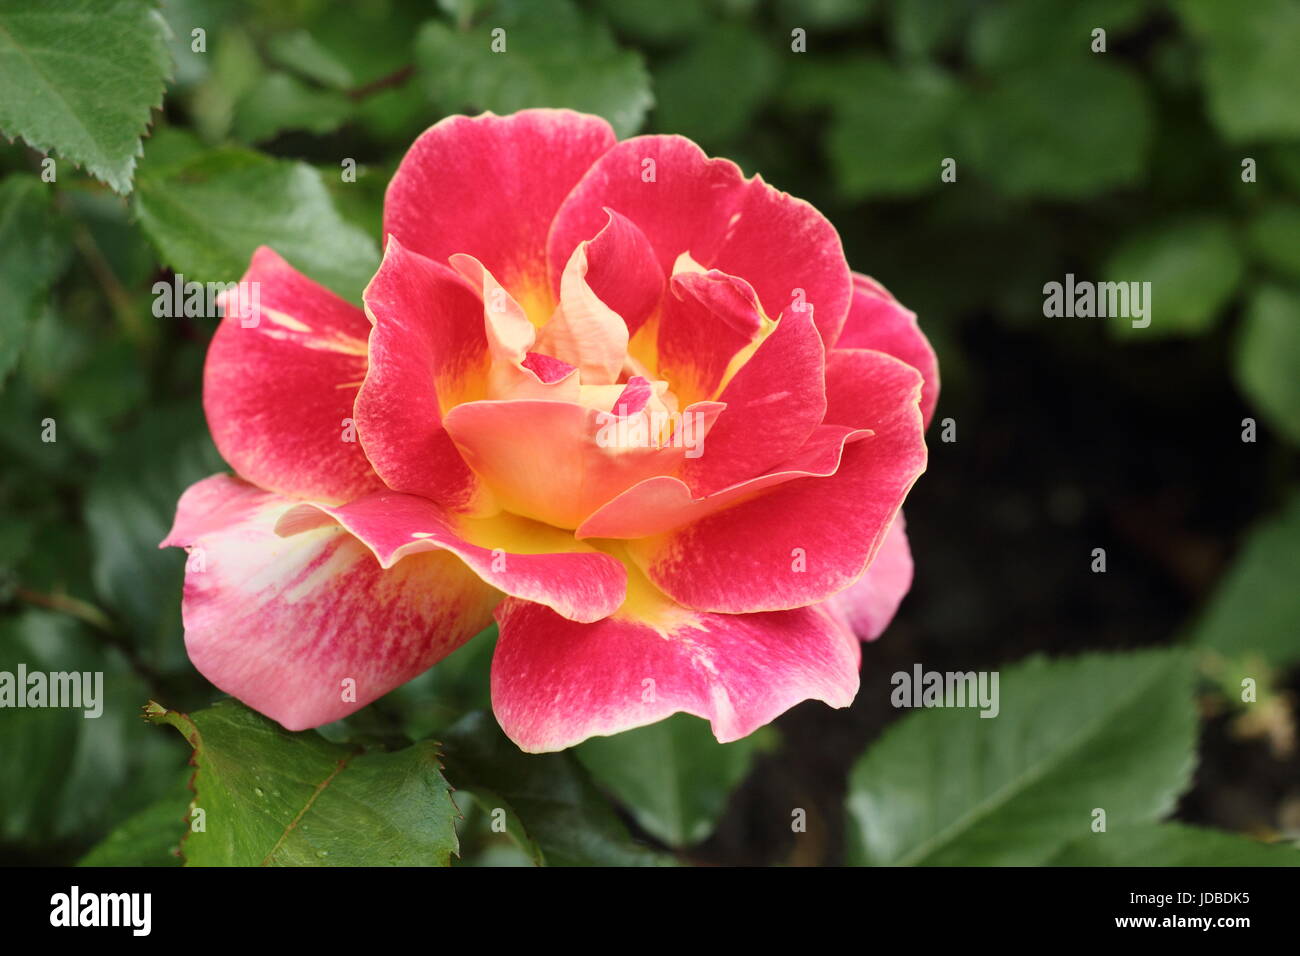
[547,137,852,342]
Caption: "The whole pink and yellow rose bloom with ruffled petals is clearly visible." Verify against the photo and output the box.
[163,109,939,752]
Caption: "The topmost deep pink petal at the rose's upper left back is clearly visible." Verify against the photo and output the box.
[384,110,615,308]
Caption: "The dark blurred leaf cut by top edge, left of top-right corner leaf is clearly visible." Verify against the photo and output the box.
[972,0,1152,72]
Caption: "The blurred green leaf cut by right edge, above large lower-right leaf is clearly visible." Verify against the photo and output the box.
[1192,490,1300,665]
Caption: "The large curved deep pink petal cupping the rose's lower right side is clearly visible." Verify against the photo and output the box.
[628,349,926,614]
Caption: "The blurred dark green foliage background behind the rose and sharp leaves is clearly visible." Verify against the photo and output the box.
[0,0,1300,864]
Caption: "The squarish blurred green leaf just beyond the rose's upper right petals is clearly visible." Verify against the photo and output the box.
[814,60,962,199]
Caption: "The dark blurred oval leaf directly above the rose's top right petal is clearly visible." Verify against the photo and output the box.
[655,25,779,147]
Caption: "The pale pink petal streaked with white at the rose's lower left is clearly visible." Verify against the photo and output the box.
[164,475,499,730]
